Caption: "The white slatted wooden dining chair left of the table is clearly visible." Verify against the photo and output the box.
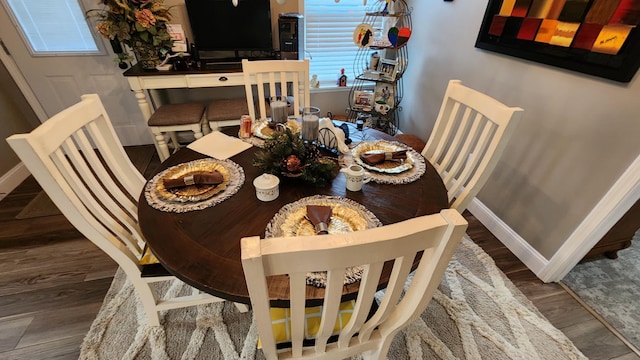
[7,94,248,326]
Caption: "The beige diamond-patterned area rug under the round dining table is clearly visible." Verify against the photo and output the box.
[80,239,586,360]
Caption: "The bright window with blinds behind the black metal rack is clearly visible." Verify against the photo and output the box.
[304,0,376,87]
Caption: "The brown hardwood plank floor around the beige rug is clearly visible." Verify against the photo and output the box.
[0,145,640,360]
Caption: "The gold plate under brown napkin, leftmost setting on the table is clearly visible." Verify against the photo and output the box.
[156,159,231,202]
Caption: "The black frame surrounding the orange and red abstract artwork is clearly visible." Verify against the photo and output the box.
[475,0,640,83]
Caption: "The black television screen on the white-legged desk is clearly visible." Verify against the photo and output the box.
[185,0,273,51]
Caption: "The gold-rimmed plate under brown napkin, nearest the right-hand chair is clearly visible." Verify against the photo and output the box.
[351,140,415,174]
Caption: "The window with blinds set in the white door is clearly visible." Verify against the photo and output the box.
[4,0,100,55]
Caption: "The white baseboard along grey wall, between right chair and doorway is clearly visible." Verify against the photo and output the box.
[467,198,549,277]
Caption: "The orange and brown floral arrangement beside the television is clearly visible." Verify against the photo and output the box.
[87,0,173,69]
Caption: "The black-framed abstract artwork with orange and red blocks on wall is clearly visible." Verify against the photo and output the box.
[476,0,640,82]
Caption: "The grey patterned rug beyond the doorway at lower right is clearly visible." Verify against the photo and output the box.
[562,231,640,349]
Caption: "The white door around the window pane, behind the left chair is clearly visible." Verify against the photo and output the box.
[0,0,153,145]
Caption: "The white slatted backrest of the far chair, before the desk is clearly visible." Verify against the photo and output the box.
[242,59,311,120]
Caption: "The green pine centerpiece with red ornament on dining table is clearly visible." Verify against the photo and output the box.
[253,128,339,186]
